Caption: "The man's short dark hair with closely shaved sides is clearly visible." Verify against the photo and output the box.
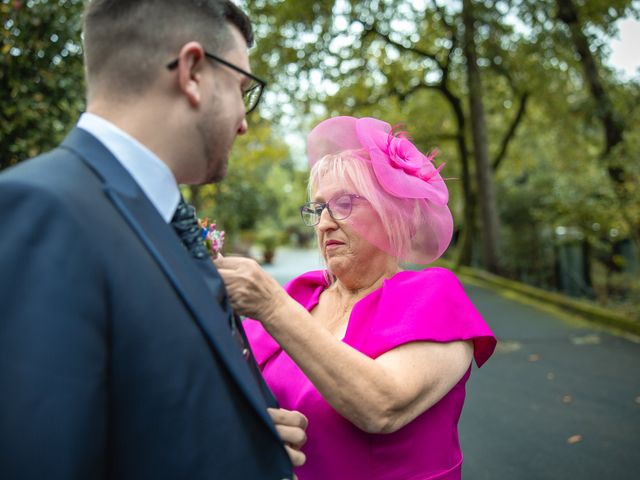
[83,0,253,94]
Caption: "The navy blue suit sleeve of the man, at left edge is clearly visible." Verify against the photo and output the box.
[0,181,108,480]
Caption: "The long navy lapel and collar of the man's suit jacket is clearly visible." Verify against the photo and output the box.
[61,128,275,433]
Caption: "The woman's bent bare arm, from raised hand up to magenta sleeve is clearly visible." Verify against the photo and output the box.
[214,257,473,433]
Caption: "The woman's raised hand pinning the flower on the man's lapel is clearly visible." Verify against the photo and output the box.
[213,255,289,321]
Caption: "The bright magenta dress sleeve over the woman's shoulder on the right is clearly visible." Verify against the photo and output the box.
[344,267,496,366]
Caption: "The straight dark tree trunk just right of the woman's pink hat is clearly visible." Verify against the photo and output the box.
[462,0,500,273]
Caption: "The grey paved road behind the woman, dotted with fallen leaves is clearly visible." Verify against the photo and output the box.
[267,250,640,480]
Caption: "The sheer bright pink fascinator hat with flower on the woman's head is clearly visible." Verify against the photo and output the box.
[307,116,453,264]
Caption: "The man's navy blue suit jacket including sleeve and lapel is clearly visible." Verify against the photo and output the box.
[0,128,292,480]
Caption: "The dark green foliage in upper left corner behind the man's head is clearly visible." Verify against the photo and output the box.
[0,0,84,169]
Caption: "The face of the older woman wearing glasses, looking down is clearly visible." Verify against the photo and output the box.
[311,176,387,277]
